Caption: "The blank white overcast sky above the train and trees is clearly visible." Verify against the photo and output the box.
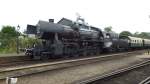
[0,0,150,33]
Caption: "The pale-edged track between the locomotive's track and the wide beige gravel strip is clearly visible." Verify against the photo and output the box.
[0,51,143,79]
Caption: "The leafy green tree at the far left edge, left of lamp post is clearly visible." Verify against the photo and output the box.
[0,26,19,52]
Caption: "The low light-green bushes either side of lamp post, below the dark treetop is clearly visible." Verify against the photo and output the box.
[0,37,37,53]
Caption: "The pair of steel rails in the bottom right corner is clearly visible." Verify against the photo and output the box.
[73,57,150,84]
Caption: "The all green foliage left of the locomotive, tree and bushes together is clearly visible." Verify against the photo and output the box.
[0,26,36,53]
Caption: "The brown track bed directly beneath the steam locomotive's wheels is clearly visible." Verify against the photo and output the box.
[0,51,144,67]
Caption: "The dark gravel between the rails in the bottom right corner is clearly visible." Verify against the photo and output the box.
[89,59,150,84]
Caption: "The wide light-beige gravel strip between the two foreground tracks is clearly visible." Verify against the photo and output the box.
[0,55,148,84]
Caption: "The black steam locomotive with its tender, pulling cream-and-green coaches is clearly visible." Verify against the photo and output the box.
[25,17,150,59]
